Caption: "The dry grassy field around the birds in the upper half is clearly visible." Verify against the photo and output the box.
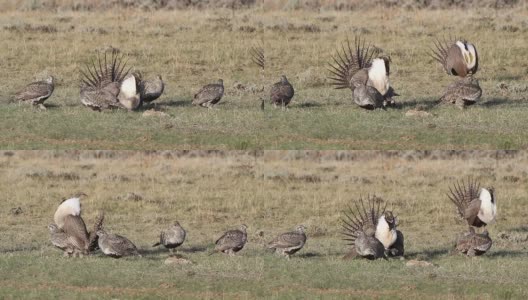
[0,8,528,149]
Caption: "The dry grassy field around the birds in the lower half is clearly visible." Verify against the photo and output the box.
[0,151,528,299]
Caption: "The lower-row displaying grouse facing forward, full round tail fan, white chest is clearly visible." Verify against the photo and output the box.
[342,196,404,259]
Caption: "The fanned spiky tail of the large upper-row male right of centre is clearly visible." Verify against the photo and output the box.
[328,36,375,90]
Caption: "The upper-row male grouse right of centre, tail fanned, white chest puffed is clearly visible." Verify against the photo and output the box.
[329,37,398,110]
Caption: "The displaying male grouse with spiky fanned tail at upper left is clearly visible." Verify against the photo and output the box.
[81,50,140,111]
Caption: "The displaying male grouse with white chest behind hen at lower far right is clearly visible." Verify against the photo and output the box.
[447,177,497,231]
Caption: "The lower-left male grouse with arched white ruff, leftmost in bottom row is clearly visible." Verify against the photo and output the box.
[53,193,90,255]
